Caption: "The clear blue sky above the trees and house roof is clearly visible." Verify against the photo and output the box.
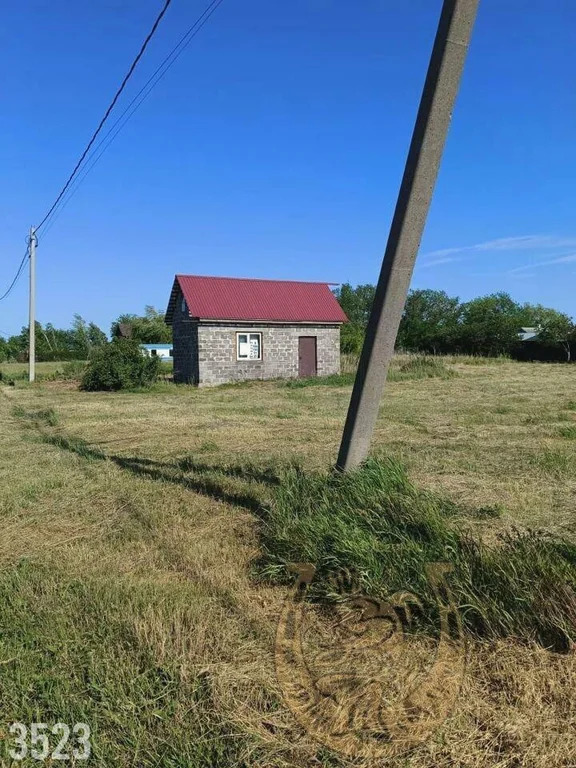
[0,0,576,333]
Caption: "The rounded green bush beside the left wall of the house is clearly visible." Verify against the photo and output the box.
[80,339,161,392]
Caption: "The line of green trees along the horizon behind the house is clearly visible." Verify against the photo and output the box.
[0,292,576,362]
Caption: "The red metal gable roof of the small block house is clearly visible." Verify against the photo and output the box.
[166,275,347,323]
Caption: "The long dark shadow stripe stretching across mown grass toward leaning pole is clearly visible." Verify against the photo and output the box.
[41,432,280,512]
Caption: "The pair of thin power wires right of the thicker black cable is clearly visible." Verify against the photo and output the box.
[38,0,223,235]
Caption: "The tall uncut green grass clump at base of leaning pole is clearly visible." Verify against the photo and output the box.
[259,460,576,649]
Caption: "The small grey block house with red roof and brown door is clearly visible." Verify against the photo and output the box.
[166,275,347,386]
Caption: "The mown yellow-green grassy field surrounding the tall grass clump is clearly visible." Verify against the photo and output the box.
[0,358,576,768]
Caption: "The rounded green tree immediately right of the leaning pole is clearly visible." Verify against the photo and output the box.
[396,289,462,354]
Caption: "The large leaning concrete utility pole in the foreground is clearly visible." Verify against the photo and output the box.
[337,0,479,470]
